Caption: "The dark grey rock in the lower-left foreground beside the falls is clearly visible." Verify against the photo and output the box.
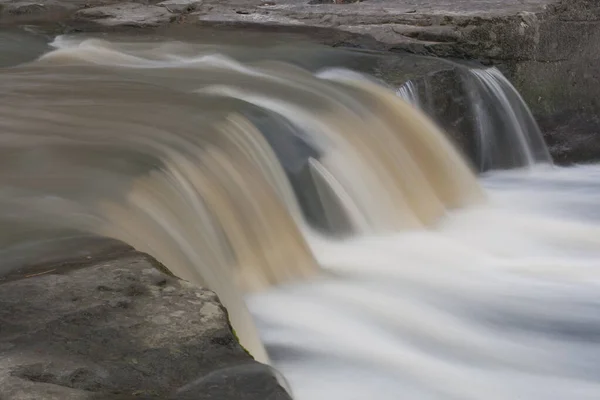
[0,242,289,400]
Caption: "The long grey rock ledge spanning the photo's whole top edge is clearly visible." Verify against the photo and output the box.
[0,0,600,63]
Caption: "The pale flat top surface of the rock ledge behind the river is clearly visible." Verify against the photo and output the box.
[0,0,560,32]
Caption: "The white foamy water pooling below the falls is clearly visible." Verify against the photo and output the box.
[250,166,600,400]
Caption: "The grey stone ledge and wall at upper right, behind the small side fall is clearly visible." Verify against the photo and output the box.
[183,0,600,162]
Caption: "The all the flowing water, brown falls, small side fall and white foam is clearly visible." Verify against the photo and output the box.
[0,32,600,400]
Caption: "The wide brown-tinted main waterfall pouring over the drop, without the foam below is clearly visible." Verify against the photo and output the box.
[0,39,483,361]
